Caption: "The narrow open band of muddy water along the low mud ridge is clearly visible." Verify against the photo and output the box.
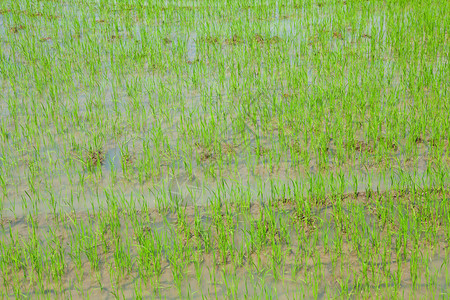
[3,152,442,217]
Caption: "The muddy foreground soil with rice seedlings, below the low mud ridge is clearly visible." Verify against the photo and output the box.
[1,190,450,299]
